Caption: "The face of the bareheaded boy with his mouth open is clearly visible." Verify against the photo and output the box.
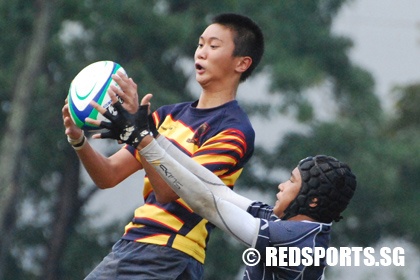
[194,24,241,87]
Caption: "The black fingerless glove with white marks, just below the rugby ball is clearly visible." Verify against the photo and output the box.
[99,102,150,148]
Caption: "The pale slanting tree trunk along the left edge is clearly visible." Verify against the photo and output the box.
[0,0,53,278]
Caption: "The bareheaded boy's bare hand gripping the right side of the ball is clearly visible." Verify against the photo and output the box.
[108,72,139,114]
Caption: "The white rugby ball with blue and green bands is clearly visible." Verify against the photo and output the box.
[67,61,126,130]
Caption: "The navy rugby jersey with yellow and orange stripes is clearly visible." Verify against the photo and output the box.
[122,100,255,263]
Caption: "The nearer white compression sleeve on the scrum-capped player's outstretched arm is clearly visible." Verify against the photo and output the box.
[140,140,260,247]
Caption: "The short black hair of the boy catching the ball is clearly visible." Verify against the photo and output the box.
[212,13,264,82]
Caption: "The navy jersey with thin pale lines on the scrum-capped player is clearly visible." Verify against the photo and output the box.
[243,202,331,280]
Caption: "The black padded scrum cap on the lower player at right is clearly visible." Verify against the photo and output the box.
[282,155,356,223]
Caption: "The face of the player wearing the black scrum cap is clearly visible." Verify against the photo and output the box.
[273,167,302,218]
